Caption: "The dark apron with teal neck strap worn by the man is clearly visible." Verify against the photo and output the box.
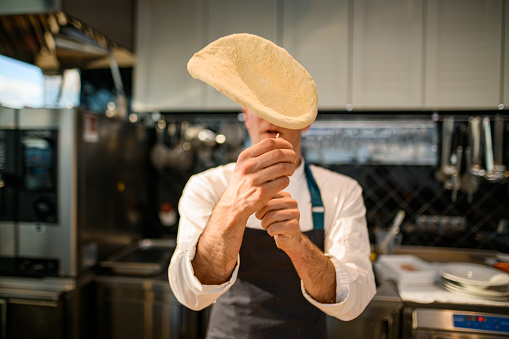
[207,164,326,339]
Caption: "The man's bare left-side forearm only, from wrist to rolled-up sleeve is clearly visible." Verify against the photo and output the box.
[192,204,246,285]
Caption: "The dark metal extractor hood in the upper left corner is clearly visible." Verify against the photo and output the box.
[0,0,134,73]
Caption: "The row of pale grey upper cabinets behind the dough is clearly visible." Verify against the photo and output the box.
[133,0,509,112]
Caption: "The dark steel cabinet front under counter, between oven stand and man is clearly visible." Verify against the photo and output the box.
[95,270,202,339]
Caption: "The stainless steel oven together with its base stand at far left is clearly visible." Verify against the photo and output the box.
[0,108,147,339]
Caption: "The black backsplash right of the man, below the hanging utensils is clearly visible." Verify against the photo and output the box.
[330,165,509,252]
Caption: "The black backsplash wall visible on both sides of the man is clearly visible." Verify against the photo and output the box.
[147,113,509,253]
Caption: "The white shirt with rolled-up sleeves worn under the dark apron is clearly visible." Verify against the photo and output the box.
[168,162,376,320]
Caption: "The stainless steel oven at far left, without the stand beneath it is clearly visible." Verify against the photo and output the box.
[0,109,146,277]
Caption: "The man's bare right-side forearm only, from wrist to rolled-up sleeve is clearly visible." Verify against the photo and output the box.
[287,235,336,304]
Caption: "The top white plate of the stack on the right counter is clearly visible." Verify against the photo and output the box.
[440,263,509,286]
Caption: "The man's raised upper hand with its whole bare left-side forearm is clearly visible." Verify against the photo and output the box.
[192,138,297,285]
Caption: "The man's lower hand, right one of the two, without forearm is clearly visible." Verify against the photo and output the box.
[255,191,302,252]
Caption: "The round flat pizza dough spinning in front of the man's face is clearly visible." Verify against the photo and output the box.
[187,33,318,129]
